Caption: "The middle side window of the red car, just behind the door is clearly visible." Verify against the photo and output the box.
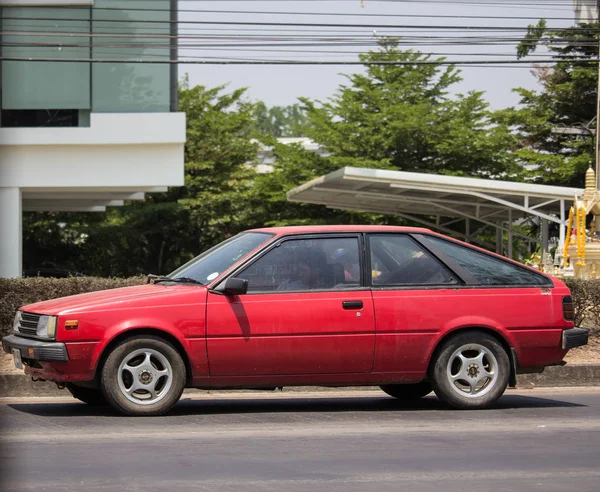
[369,234,458,286]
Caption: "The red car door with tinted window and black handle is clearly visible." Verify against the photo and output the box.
[207,234,375,376]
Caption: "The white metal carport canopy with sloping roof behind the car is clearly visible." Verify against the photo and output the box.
[287,167,583,254]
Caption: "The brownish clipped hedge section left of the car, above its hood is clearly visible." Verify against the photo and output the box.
[0,277,146,336]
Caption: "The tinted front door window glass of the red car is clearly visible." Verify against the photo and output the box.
[237,238,360,293]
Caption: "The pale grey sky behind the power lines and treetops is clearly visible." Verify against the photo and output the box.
[179,0,574,109]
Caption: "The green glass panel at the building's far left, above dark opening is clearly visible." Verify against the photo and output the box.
[1,7,90,109]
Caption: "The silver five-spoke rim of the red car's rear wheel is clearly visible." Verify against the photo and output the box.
[446,343,498,398]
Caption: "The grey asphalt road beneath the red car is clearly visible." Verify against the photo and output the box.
[0,389,600,492]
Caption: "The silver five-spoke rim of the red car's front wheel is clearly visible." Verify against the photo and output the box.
[118,349,173,405]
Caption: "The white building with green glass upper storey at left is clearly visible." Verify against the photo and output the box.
[0,0,185,277]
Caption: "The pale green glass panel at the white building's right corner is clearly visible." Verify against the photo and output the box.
[92,0,171,113]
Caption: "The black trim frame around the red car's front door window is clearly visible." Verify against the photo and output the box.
[216,232,368,297]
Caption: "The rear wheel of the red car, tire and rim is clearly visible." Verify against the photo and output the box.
[429,331,510,410]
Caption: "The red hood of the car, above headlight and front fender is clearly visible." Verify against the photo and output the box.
[19,284,206,315]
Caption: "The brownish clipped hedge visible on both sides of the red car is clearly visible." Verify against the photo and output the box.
[0,277,600,336]
